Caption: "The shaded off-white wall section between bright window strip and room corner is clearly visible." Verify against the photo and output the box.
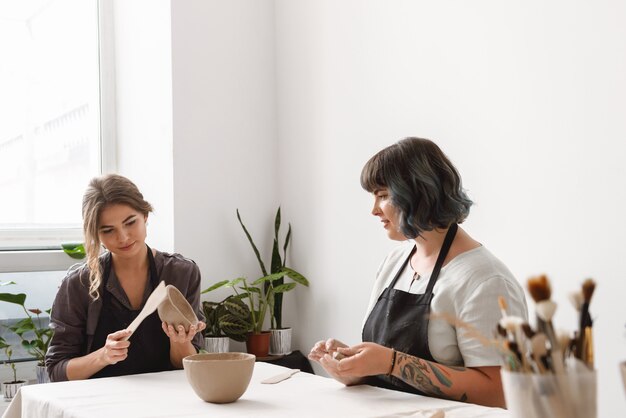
[172,0,280,350]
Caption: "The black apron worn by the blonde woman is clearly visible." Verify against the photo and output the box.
[90,245,174,378]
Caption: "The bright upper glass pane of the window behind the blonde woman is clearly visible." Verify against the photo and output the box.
[0,0,110,255]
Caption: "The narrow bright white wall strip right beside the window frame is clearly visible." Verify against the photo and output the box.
[113,0,174,251]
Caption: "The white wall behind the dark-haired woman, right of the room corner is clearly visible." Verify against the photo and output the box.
[276,0,626,417]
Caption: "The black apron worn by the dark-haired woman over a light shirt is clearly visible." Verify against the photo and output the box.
[362,224,458,395]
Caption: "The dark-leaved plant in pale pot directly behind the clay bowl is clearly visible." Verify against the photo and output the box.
[202,285,250,353]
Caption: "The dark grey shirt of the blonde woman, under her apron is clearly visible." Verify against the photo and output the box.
[46,251,204,382]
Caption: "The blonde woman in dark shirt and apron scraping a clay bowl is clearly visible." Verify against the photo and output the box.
[46,174,205,381]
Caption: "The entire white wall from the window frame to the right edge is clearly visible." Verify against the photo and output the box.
[109,0,626,417]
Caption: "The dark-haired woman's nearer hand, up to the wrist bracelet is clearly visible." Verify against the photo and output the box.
[330,343,393,377]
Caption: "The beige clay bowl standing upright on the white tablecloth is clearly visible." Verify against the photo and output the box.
[183,353,256,403]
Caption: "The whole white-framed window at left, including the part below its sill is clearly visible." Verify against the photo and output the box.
[0,0,115,361]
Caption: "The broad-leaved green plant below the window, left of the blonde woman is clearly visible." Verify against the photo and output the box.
[0,282,54,366]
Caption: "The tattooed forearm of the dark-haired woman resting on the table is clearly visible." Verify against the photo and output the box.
[396,353,467,399]
